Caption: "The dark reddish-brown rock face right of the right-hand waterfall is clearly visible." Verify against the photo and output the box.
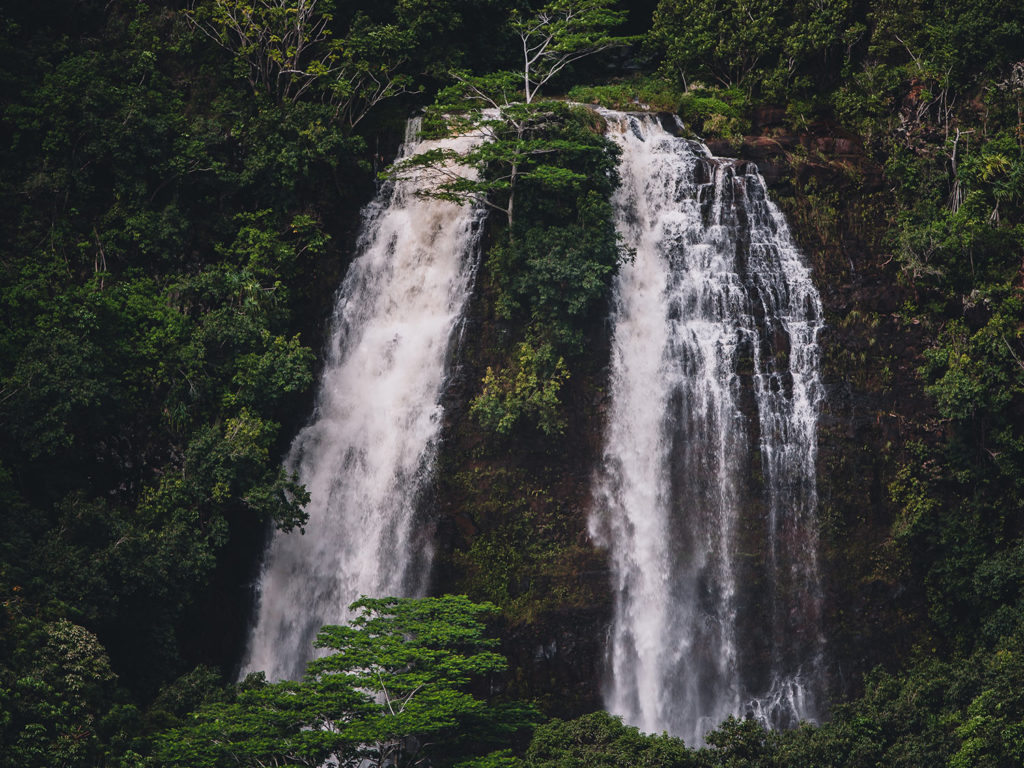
[709,109,934,696]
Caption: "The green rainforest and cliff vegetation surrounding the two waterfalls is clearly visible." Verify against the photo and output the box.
[0,0,1024,768]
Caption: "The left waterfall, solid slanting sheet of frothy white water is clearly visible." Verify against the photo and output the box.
[243,121,482,680]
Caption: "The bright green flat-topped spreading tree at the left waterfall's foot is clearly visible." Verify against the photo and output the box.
[155,595,536,768]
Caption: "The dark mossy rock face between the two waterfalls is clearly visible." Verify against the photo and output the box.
[428,225,610,717]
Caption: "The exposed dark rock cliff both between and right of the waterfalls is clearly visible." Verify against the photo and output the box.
[430,109,932,716]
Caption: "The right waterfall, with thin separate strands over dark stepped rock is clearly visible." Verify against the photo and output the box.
[591,112,823,744]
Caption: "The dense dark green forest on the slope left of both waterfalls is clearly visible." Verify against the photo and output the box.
[0,0,540,767]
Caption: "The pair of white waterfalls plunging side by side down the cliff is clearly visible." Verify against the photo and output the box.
[245,112,823,744]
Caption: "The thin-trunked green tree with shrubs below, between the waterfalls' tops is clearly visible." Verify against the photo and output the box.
[387,0,628,436]
